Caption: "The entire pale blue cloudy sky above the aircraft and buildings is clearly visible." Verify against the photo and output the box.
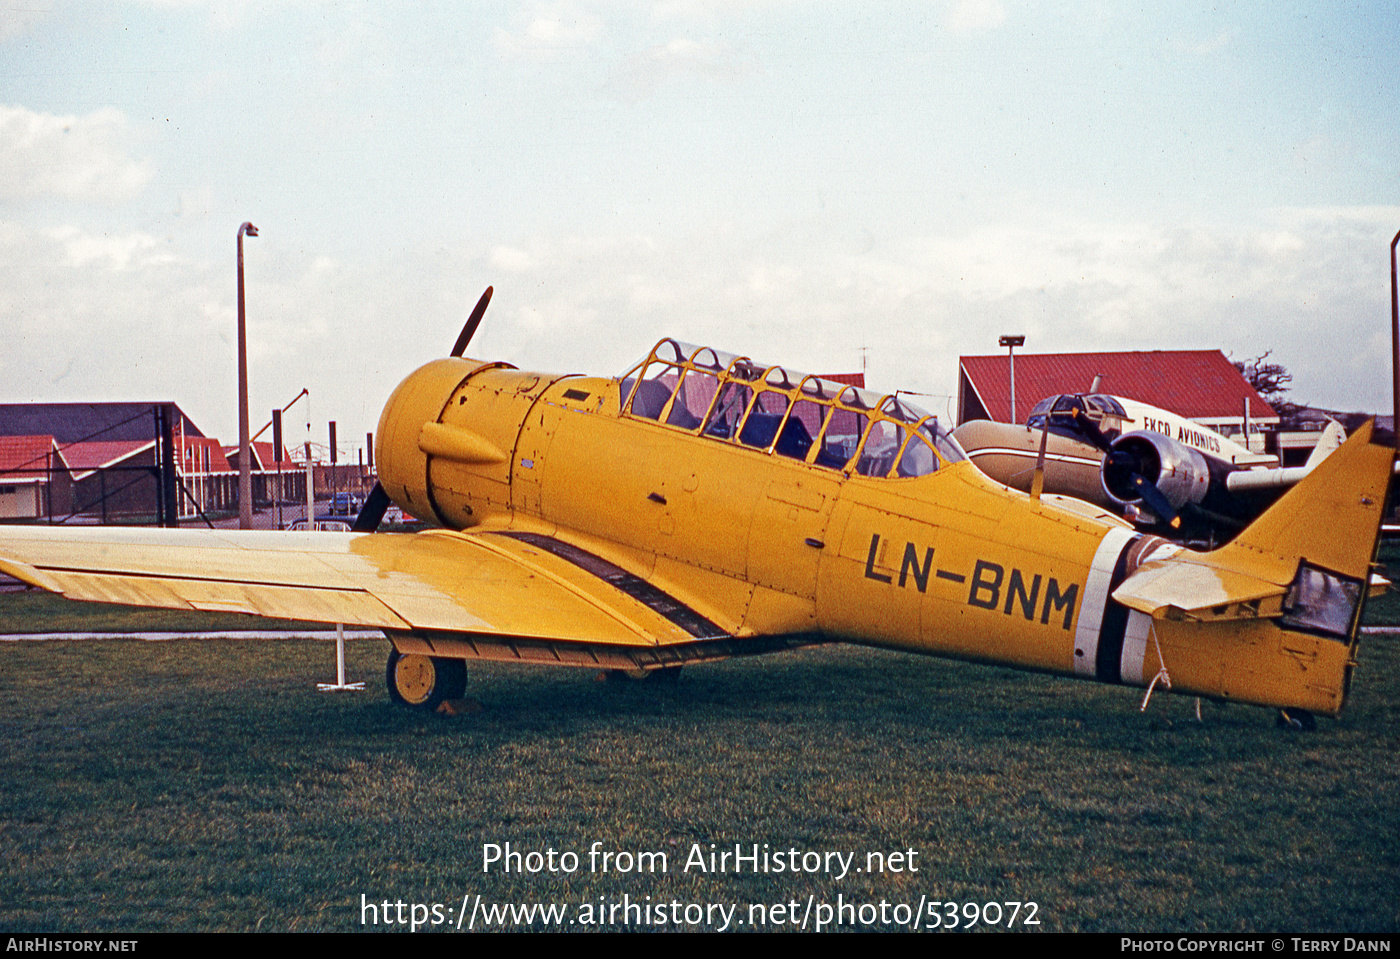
[0,0,1400,459]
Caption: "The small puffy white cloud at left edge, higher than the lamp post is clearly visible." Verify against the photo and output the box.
[0,105,151,203]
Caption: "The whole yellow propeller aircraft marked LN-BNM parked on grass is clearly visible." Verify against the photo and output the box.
[0,285,1394,725]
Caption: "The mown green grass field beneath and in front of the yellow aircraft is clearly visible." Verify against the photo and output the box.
[0,640,1400,932]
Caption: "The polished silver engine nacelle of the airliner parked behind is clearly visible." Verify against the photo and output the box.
[1099,430,1228,510]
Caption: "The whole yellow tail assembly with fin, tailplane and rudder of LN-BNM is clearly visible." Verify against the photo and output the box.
[1113,423,1396,715]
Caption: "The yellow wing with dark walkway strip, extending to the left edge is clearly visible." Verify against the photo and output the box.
[0,528,727,647]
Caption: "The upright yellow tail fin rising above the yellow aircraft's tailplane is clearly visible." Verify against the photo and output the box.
[1211,423,1396,584]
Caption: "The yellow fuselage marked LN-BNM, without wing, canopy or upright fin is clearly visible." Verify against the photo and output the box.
[377,347,1351,715]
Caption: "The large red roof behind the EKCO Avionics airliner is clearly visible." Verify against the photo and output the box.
[958,350,1278,435]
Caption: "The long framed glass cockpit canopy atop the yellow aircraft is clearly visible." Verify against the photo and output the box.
[622,339,966,477]
